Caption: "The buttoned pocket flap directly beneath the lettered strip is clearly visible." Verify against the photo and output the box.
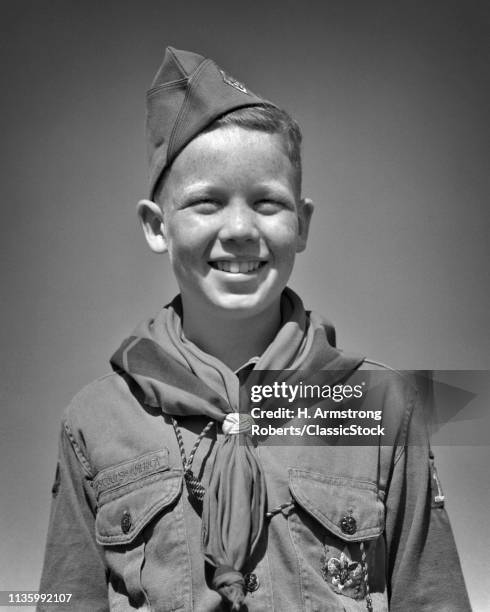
[95,469,182,546]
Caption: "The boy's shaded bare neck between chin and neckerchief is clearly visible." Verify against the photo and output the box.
[183,304,281,371]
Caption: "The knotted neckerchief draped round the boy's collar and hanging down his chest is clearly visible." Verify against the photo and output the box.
[111,289,363,610]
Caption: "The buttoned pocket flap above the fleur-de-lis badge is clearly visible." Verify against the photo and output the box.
[289,468,384,542]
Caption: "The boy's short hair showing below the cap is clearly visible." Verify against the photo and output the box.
[154,104,302,201]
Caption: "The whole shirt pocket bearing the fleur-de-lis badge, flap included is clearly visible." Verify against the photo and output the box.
[288,468,385,610]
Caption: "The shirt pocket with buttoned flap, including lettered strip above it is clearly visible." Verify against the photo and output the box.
[94,449,191,611]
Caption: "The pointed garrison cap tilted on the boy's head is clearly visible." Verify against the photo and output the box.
[146,47,274,198]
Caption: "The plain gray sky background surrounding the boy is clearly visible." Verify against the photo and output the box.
[0,0,490,611]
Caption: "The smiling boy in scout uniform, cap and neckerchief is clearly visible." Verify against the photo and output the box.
[41,48,469,612]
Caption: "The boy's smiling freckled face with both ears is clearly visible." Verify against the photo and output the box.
[139,126,312,321]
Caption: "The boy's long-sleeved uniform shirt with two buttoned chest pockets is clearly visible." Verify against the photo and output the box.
[39,361,470,612]
